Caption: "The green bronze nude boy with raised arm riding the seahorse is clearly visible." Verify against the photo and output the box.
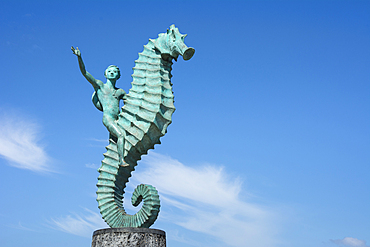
[71,46,128,166]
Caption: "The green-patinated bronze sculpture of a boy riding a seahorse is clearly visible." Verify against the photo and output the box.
[72,25,195,228]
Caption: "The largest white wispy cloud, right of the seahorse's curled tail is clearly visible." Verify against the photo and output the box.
[133,152,278,247]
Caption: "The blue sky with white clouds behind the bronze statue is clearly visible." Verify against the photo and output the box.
[0,0,370,247]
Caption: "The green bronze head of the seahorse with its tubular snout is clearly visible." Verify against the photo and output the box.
[151,25,195,61]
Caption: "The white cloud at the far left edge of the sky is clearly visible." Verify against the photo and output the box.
[0,113,52,172]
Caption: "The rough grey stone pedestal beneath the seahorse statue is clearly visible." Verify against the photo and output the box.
[91,227,166,247]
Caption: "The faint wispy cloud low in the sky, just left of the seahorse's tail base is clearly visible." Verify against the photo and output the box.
[48,209,108,238]
